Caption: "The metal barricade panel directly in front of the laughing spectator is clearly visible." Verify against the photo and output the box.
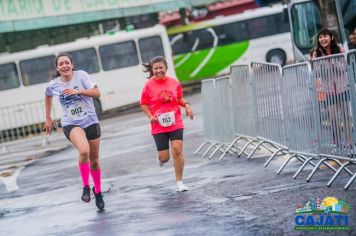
[312,54,354,157]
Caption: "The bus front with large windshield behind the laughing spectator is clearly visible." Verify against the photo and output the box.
[288,0,356,61]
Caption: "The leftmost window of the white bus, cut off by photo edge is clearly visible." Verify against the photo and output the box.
[0,63,20,91]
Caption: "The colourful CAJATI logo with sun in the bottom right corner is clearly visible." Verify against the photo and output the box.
[294,197,351,230]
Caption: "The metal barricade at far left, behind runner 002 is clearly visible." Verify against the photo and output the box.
[0,100,62,143]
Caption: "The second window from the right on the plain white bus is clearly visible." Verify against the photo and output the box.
[99,41,138,71]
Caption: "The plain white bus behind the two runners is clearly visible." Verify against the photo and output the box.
[0,25,176,130]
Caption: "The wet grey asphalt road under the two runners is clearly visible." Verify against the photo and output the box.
[0,93,356,235]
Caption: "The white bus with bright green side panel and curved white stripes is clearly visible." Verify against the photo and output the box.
[167,4,294,82]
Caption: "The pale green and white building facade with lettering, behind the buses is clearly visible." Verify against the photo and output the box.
[0,0,217,53]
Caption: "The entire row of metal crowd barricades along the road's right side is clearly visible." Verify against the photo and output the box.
[195,53,356,189]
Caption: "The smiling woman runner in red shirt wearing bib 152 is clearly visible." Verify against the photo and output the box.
[140,57,194,192]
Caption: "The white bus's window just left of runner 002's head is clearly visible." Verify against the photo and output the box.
[20,55,56,86]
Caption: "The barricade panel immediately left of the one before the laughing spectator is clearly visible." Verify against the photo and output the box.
[282,62,319,156]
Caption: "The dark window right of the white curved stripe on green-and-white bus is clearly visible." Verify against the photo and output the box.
[214,22,248,46]
